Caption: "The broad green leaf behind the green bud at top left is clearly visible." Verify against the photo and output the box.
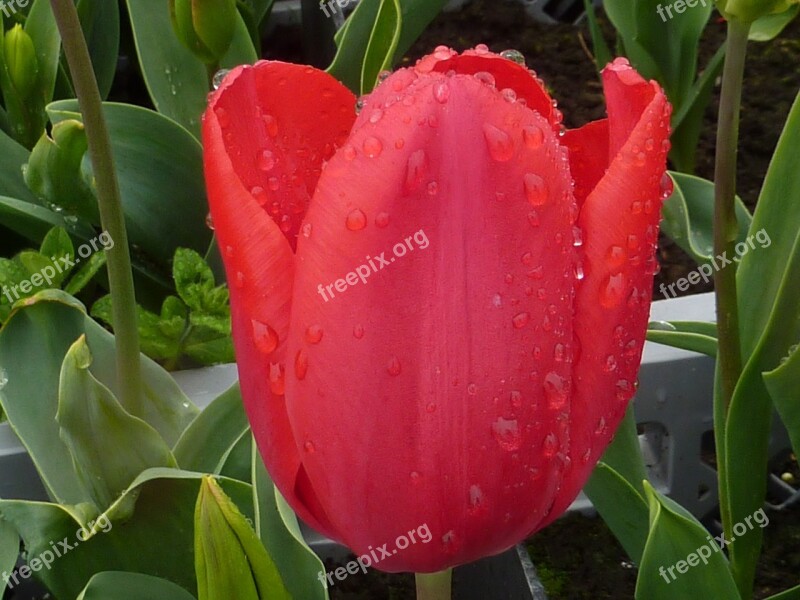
[127,0,258,138]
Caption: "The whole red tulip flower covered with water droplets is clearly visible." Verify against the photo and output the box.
[203,47,671,572]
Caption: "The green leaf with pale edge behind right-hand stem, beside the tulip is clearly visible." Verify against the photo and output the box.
[661,171,752,268]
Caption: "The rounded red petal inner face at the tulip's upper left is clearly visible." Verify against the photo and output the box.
[210,61,355,248]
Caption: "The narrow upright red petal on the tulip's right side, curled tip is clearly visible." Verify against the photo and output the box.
[545,59,671,524]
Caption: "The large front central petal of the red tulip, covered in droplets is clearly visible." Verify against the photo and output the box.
[287,71,577,572]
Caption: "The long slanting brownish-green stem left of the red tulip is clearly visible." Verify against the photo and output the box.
[50,0,143,416]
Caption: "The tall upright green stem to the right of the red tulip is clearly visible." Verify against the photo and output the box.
[714,20,750,592]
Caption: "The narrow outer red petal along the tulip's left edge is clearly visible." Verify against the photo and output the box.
[203,69,340,531]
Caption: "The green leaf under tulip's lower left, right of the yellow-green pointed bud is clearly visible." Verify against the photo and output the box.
[252,450,328,600]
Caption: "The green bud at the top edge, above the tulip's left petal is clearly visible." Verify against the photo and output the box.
[169,0,237,65]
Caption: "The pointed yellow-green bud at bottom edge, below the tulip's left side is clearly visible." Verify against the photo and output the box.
[195,476,291,600]
